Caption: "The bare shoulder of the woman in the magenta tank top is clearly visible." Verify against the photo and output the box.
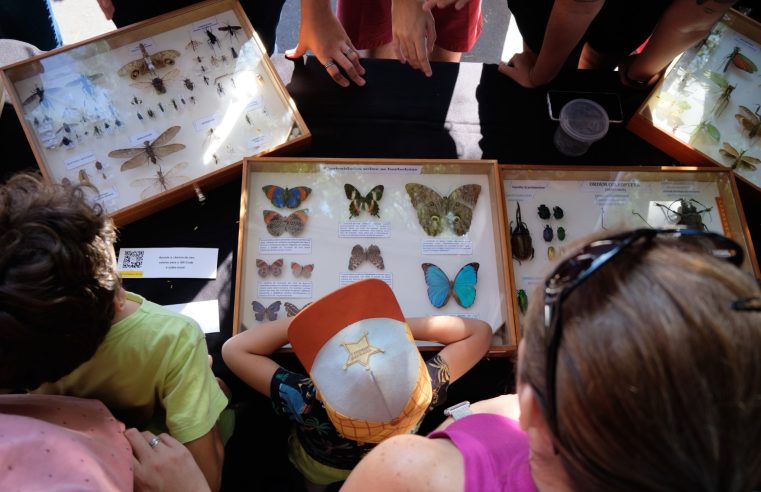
[341,434,465,492]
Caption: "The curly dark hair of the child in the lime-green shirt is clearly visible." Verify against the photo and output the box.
[0,174,120,389]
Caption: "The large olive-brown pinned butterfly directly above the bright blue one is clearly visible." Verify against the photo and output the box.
[405,183,481,236]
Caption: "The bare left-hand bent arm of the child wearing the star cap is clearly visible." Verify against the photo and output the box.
[222,318,292,397]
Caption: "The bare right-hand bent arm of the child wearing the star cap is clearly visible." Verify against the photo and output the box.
[407,316,492,382]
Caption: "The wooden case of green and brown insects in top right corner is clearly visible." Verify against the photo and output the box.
[628,10,761,191]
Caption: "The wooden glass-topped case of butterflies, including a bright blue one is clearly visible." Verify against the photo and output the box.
[233,158,515,353]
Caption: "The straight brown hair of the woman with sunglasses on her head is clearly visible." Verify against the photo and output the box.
[519,232,761,492]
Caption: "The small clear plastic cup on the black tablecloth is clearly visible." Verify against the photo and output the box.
[553,99,608,157]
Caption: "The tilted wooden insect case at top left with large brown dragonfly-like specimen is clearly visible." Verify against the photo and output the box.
[0,0,310,224]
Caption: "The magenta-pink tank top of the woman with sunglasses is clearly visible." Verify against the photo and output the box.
[428,413,537,492]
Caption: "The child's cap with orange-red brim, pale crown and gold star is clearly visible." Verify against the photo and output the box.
[288,279,432,442]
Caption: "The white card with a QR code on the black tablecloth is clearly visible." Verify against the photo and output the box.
[117,248,219,279]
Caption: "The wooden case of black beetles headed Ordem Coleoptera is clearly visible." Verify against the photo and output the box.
[500,165,759,334]
